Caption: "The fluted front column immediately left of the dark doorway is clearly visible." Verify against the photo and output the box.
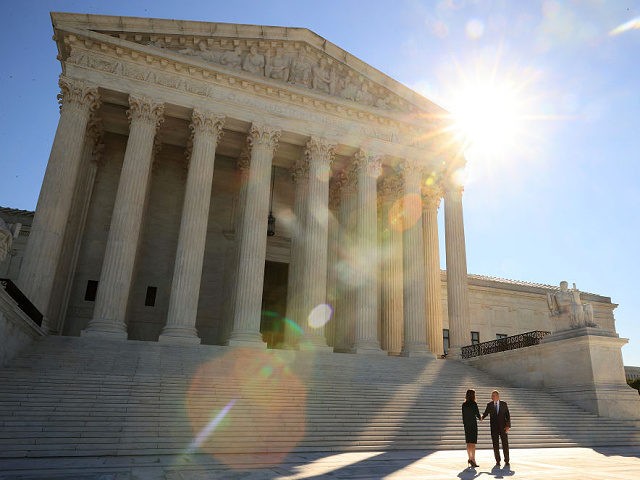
[228,124,280,348]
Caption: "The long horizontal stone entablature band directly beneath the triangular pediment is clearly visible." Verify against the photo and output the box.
[57,28,456,155]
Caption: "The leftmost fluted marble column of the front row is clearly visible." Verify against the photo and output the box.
[18,76,100,329]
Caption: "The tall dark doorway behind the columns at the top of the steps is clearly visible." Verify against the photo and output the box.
[260,262,289,348]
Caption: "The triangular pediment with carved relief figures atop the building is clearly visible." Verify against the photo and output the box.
[51,13,446,120]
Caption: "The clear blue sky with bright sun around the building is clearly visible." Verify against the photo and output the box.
[0,0,640,366]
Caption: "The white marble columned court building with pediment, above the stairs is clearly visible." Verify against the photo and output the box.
[0,13,615,356]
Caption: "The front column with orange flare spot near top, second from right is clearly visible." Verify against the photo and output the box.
[402,161,433,357]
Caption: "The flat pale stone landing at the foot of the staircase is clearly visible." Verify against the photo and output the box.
[0,447,640,480]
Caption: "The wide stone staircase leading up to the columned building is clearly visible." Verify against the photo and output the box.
[0,337,640,463]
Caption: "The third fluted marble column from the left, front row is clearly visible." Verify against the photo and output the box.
[159,109,224,344]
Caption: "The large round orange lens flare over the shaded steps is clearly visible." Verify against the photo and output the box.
[186,348,307,469]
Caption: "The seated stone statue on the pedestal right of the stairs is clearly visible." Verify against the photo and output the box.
[547,280,597,331]
